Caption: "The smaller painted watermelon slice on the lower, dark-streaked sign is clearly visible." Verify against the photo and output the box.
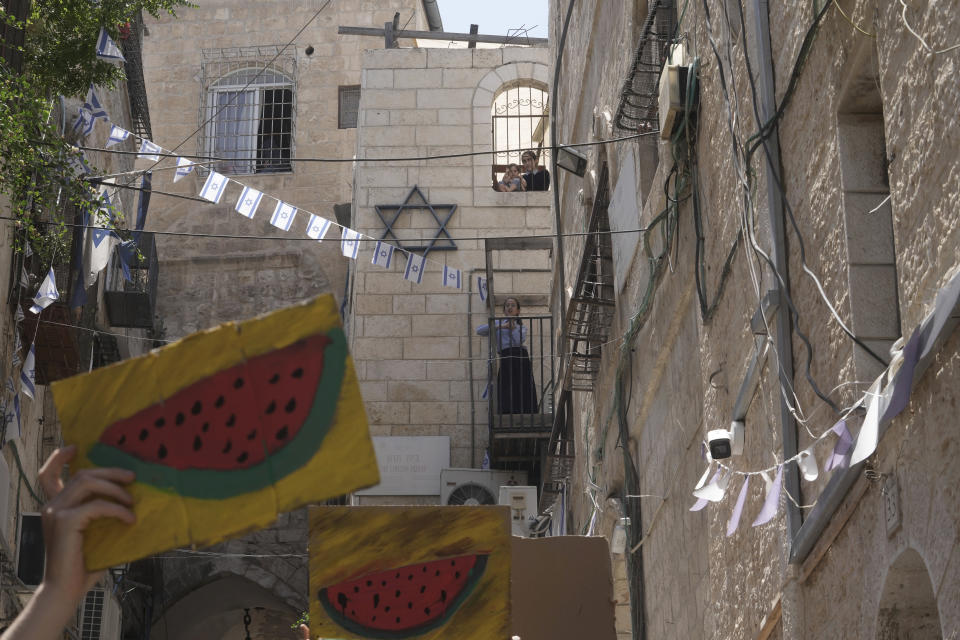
[317,555,487,639]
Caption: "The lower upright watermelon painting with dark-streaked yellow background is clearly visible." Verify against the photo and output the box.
[310,507,510,640]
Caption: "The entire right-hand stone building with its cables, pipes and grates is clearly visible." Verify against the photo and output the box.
[550,0,960,638]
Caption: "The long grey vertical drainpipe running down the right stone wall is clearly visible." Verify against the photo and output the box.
[753,0,803,547]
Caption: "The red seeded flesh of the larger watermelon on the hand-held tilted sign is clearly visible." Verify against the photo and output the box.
[100,334,330,470]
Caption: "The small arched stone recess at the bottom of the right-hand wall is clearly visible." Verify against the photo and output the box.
[876,548,943,640]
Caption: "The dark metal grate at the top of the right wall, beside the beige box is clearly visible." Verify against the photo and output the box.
[614,0,675,139]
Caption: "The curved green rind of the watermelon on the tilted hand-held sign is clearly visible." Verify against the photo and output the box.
[87,328,347,500]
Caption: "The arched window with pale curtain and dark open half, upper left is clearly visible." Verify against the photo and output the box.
[202,68,294,174]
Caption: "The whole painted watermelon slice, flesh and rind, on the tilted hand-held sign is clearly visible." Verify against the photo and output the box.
[88,329,347,499]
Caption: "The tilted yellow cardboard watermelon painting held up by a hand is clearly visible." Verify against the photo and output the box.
[53,296,379,569]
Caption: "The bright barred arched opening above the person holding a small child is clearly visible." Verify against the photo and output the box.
[491,85,550,181]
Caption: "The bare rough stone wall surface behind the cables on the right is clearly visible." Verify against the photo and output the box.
[551,1,960,638]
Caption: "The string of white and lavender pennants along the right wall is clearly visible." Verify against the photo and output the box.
[690,269,960,537]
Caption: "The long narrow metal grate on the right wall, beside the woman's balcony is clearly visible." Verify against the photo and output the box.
[564,165,616,391]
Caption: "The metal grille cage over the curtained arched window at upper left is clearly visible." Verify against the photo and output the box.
[200,46,296,175]
